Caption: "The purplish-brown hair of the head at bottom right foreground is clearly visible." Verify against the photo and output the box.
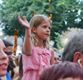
[40,62,83,80]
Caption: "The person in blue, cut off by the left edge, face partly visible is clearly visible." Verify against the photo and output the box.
[0,39,11,80]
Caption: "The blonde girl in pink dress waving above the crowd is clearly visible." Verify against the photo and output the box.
[18,15,54,80]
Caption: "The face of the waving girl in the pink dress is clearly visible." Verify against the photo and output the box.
[34,20,51,40]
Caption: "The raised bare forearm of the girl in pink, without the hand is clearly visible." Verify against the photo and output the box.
[23,29,32,56]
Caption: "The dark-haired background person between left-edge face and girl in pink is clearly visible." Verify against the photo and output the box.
[3,40,19,80]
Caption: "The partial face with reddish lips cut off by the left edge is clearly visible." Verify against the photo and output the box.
[0,41,8,76]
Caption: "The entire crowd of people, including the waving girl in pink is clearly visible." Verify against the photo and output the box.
[0,14,83,80]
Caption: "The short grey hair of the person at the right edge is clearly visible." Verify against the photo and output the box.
[62,31,83,62]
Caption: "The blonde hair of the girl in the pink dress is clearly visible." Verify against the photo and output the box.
[30,14,51,48]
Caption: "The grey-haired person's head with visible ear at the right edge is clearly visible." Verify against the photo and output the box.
[62,31,83,67]
